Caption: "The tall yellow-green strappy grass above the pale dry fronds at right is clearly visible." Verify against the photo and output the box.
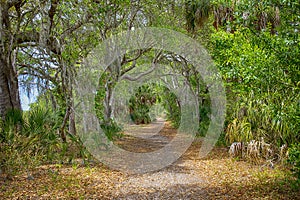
[226,93,300,146]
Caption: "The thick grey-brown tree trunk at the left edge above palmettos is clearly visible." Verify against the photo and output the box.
[0,56,21,118]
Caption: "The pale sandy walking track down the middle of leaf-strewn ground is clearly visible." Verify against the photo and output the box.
[116,118,207,199]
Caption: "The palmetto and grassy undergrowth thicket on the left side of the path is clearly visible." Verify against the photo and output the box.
[0,104,83,176]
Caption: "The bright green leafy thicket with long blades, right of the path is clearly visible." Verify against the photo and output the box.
[212,29,300,146]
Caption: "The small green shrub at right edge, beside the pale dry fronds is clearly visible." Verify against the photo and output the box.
[288,143,300,180]
